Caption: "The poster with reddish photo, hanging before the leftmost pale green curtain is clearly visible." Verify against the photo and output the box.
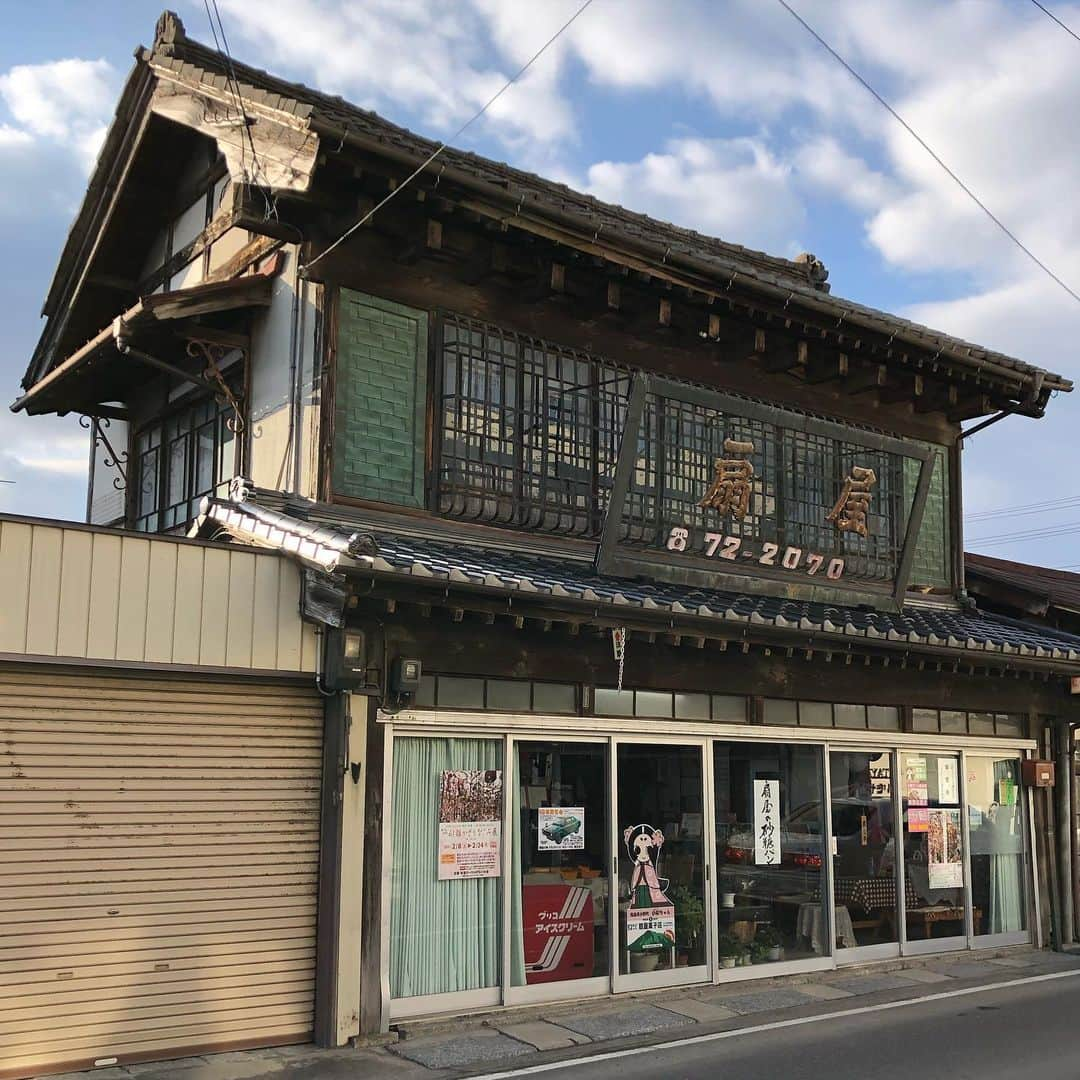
[438,769,502,881]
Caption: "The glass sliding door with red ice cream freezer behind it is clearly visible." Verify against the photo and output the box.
[508,740,611,1002]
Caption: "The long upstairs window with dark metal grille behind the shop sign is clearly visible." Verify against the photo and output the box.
[435,315,950,588]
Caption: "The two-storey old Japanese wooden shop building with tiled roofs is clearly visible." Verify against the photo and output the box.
[8,10,1080,1071]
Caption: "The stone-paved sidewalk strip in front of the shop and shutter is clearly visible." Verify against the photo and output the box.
[54,947,1080,1080]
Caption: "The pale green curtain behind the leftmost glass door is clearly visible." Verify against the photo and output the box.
[390,737,505,998]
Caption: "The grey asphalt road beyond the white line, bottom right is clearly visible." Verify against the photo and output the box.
[477,977,1080,1080]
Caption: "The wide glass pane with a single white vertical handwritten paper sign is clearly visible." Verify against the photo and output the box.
[713,741,832,977]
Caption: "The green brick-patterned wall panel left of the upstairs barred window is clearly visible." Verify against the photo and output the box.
[330,289,428,507]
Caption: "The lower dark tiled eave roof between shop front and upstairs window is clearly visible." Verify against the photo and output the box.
[203,501,1080,663]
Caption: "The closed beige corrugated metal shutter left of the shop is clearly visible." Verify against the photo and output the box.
[0,666,323,1077]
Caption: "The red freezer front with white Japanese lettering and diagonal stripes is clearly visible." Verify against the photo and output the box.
[522,885,593,985]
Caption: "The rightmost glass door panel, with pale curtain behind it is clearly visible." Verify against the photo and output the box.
[964,753,1030,946]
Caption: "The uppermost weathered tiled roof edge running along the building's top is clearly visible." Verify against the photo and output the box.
[141,14,1072,390]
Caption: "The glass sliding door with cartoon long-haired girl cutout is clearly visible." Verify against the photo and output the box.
[611,742,711,989]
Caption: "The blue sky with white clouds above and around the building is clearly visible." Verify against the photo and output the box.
[0,0,1080,566]
